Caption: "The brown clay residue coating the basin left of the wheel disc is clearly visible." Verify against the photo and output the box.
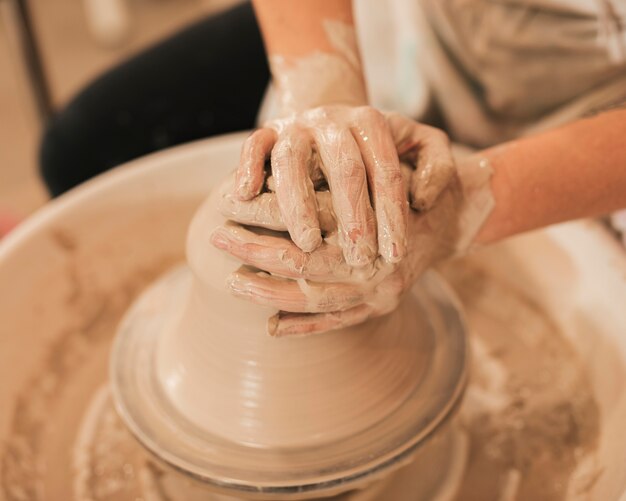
[0,211,182,501]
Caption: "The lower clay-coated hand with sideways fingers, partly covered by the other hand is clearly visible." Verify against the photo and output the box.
[212,161,476,336]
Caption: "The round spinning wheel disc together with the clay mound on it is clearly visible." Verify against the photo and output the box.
[110,146,467,499]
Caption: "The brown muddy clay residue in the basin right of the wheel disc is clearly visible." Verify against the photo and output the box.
[438,263,601,501]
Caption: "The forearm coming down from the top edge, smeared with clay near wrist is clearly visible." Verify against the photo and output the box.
[253,0,367,115]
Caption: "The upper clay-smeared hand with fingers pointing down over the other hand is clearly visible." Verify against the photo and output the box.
[235,105,454,266]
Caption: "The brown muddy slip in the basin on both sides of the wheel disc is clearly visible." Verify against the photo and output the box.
[0,250,600,501]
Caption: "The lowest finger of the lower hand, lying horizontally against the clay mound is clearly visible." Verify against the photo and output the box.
[267,304,374,337]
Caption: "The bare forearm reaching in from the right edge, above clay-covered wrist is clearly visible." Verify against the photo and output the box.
[468,110,626,243]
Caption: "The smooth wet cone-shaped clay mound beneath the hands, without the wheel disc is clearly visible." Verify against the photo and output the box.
[156,186,433,447]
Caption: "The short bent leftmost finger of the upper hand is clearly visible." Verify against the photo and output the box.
[235,128,276,200]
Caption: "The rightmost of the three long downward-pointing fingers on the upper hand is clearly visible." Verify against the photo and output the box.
[354,108,408,263]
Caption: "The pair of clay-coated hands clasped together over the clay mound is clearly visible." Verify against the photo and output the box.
[207,107,486,336]
